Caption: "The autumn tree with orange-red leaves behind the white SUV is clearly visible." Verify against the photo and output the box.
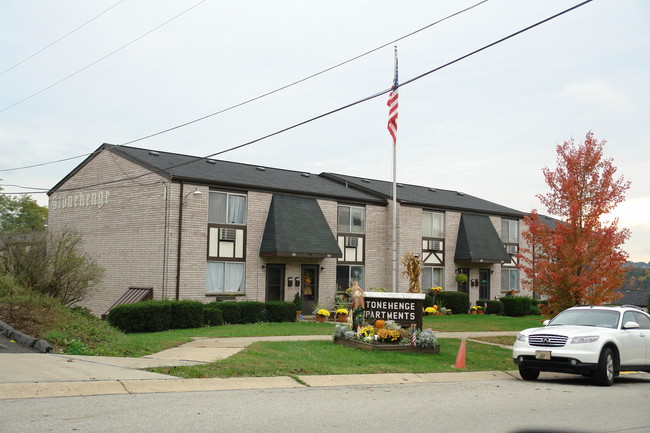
[518,132,630,314]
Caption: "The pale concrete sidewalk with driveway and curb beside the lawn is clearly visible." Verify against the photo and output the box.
[0,332,518,400]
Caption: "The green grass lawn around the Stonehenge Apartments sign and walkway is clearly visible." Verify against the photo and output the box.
[135,314,544,378]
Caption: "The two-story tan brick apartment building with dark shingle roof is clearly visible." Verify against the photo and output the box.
[48,144,524,315]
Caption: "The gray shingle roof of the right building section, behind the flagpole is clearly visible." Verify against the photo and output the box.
[322,173,525,218]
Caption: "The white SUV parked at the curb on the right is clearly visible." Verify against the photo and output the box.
[512,305,650,386]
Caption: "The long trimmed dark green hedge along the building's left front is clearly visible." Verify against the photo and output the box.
[108,301,296,333]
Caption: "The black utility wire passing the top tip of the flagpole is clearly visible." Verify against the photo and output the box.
[0,0,488,172]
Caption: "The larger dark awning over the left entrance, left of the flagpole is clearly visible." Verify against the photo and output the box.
[260,194,343,258]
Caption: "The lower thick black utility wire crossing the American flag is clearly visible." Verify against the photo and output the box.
[58,0,593,192]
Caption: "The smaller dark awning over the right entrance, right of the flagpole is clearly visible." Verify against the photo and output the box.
[454,213,510,263]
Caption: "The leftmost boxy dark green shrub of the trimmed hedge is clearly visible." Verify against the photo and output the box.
[108,301,172,332]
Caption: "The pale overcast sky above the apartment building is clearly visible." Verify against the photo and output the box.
[0,0,650,261]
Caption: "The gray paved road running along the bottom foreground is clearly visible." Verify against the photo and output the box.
[0,375,650,433]
